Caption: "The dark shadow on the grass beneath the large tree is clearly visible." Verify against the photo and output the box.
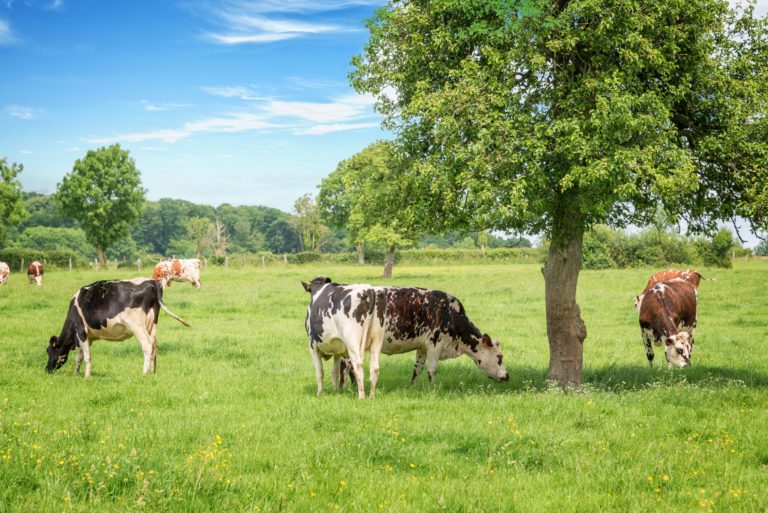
[306,361,768,397]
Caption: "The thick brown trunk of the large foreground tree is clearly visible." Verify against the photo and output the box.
[542,228,587,387]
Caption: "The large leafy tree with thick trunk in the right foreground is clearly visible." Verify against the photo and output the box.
[351,0,768,385]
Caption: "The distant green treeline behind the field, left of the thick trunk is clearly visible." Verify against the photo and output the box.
[0,193,531,267]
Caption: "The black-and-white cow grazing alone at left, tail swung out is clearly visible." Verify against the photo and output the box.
[45,278,189,378]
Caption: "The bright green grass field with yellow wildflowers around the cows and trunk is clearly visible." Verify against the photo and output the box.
[0,261,768,513]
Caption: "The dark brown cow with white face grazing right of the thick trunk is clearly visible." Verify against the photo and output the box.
[640,279,698,368]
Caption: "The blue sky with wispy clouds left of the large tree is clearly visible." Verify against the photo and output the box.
[0,0,387,211]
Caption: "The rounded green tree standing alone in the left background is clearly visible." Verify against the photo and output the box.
[56,144,144,269]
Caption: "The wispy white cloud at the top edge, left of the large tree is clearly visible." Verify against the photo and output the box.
[194,0,374,45]
